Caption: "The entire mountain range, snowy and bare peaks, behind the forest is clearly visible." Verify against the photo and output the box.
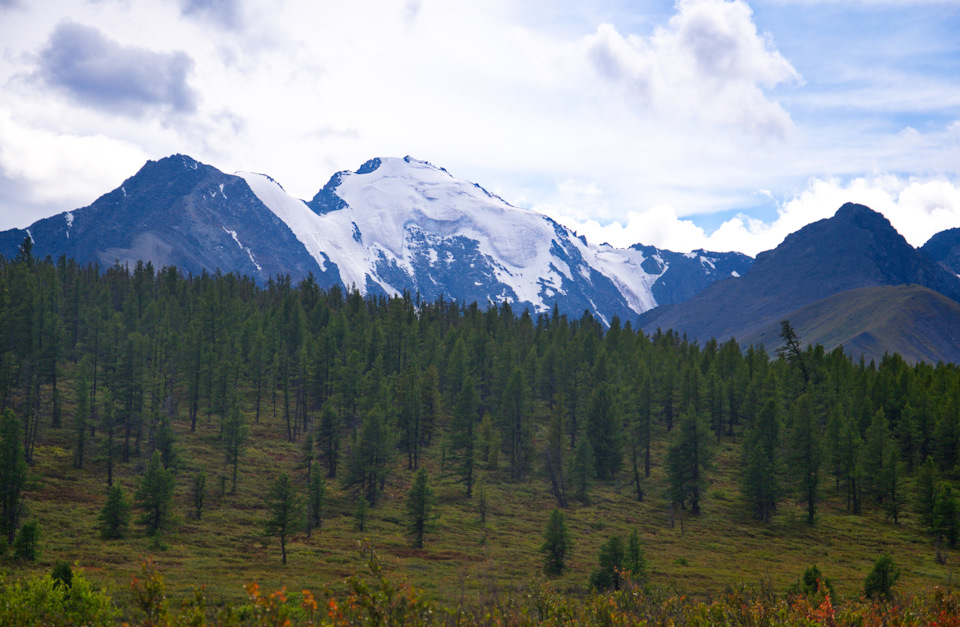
[0,155,960,363]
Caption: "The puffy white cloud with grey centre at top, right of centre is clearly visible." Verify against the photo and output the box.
[584,0,800,138]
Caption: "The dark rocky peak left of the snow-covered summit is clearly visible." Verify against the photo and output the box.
[0,155,320,282]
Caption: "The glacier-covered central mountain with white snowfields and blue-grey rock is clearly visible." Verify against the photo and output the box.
[241,157,749,321]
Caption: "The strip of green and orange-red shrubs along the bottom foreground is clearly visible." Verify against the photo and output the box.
[0,547,960,627]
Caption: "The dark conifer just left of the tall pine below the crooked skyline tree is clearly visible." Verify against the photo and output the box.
[741,400,780,522]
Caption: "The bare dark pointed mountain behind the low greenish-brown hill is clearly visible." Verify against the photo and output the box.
[641,203,960,339]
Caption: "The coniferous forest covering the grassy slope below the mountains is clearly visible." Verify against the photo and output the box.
[0,241,960,624]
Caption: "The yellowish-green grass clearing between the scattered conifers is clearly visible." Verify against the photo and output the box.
[3,402,957,607]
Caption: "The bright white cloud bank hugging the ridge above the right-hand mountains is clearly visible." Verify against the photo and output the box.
[535,175,960,256]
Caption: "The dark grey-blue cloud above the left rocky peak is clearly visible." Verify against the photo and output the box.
[39,22,197,117]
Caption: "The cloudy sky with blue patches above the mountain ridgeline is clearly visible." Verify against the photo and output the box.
[0,0,960,255]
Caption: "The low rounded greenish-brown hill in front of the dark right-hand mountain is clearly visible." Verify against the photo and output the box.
[738,285,960,363]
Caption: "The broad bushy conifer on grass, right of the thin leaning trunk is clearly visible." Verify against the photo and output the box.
[667,411,713,514]
